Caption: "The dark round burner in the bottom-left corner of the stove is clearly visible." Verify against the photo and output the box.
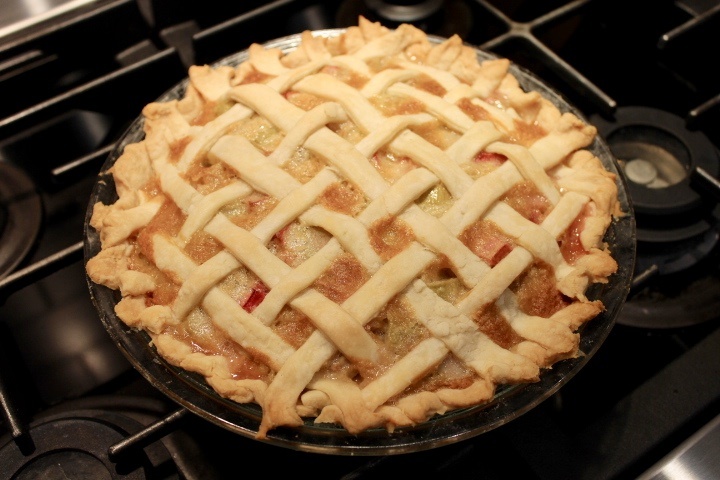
[0,396,182,480]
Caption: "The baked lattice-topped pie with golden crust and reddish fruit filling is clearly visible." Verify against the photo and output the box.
[87,18,619,438]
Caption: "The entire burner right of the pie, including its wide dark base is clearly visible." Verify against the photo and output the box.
[591,106,720,328]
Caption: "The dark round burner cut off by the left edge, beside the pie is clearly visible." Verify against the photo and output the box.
[0,161,42,278]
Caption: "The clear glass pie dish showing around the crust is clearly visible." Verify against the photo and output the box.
[85,29,635,455]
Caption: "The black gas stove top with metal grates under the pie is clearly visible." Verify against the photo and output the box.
[0,0,720,479]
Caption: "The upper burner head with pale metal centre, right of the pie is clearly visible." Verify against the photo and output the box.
[591,106,720,243]
